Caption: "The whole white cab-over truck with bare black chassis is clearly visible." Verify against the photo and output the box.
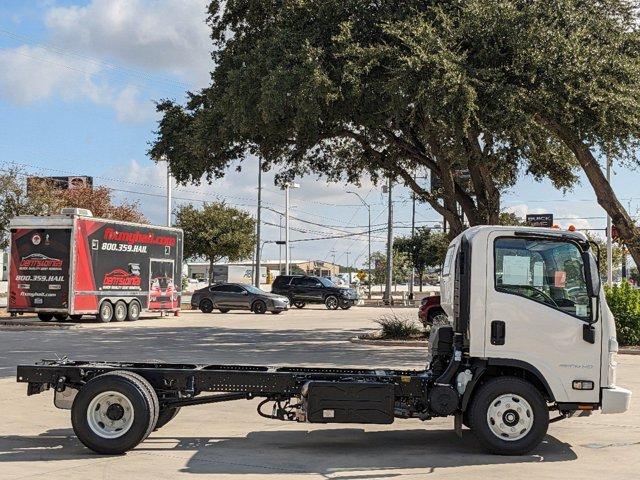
[17,226,631,455]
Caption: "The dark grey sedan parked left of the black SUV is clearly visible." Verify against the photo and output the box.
[191,283,289,314]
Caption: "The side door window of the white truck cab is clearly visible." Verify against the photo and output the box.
[494,238,591,320]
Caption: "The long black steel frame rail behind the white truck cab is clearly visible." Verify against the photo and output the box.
[17,360,431,403]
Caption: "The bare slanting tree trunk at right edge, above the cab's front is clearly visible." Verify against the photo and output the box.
[540,118,640,265]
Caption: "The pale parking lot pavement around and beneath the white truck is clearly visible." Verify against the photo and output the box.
[0,307,640,480]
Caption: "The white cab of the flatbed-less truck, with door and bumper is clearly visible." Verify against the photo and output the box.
[441,226,631,415]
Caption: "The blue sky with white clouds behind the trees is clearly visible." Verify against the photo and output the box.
[0,0,640,265]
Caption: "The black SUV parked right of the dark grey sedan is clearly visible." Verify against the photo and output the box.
[271,275,358,310]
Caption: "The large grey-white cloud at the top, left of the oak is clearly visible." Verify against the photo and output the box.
[45,0,211,85]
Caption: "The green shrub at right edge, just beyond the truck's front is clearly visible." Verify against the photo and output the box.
[605,281,640,345]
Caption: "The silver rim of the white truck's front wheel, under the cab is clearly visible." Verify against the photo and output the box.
[487,393,533,442]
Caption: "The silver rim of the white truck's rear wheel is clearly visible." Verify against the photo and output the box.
[87,391,134,438]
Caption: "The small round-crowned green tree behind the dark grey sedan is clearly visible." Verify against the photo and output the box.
[176,203,256,281]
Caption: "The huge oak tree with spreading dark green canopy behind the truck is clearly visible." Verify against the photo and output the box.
[150,0,640,261]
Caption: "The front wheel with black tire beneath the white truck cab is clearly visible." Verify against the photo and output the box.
[469,377,549,455]
